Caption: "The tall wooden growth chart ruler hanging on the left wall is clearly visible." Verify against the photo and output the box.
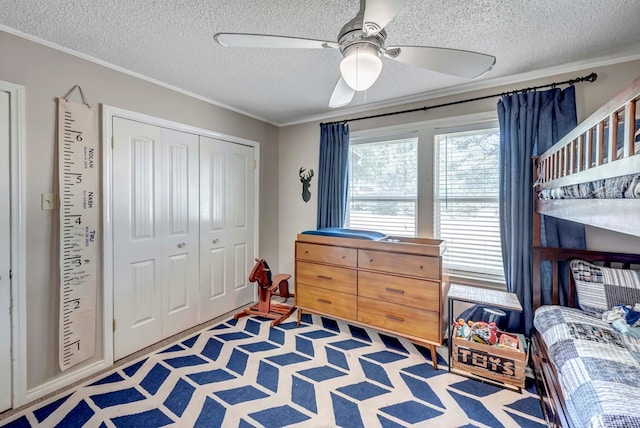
[58,85,100,371]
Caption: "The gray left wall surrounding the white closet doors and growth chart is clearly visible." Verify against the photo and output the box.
[0,32,278,389]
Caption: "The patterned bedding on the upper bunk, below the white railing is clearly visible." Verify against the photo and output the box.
[538,174,640,199]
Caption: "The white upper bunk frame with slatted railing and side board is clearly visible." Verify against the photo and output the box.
[534,72,640,236]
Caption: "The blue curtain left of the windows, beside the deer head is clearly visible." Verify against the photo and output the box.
[317,123,349,229]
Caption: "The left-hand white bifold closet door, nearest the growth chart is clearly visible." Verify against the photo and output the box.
[112,118,199,359]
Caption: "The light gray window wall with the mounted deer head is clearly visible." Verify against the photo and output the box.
[279,61,640,278]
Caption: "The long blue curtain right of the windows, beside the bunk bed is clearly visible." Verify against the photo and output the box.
[498,86,584,335]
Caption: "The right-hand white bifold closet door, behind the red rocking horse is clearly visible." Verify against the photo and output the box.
[200,137,255,321]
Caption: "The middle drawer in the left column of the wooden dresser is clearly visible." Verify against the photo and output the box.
[296,261,358,294]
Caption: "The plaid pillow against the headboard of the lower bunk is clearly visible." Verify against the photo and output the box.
[569,260,640,316]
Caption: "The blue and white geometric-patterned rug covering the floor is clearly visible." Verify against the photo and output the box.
[0,315,545,428]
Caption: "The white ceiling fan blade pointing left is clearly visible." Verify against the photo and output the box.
[213,33,338,49]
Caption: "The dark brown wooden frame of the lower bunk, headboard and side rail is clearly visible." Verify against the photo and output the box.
[531,248,640,427]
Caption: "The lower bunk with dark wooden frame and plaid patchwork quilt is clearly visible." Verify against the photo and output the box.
[531,248,640,428]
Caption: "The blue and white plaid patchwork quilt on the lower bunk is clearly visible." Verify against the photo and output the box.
[534,305,640,428]
